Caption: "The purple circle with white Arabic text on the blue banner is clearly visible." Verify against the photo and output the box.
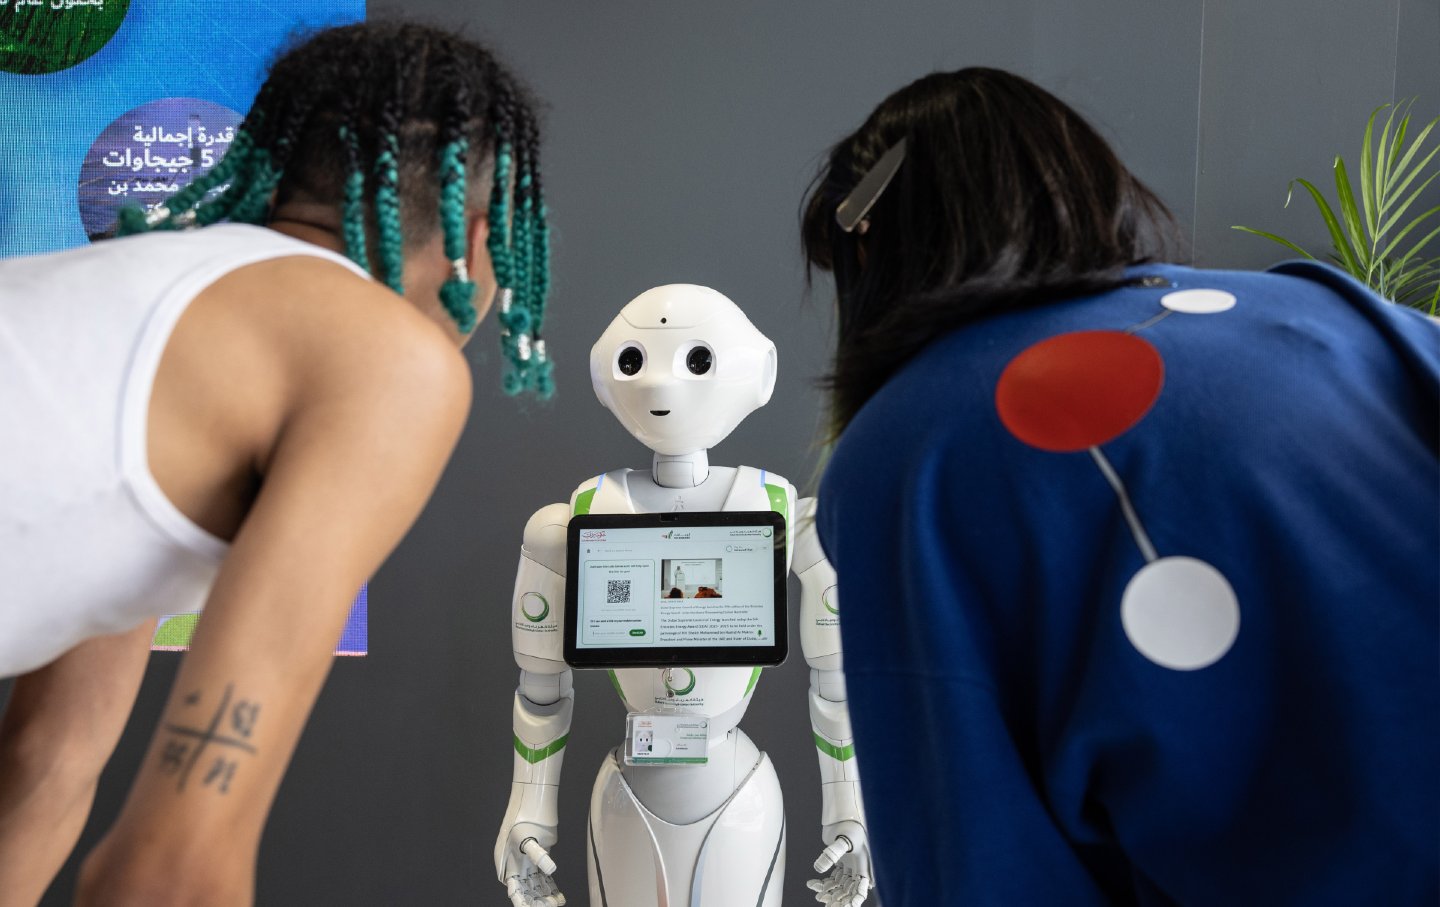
[79,98,243,239]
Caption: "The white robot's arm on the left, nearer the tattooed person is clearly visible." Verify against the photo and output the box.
[495,504,575,907]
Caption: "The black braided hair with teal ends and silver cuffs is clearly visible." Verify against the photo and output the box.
[117,23,554,397]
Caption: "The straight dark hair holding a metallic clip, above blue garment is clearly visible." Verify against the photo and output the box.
[801,68,1179,441]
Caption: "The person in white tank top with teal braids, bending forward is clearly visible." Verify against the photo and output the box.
[0,23,553,904]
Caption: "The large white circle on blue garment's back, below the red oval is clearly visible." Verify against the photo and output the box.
[1120,557,1240,671]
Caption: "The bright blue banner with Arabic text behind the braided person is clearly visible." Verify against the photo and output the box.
[0,0,369,655]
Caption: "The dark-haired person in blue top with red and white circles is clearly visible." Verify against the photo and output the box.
[802,69,1440,907]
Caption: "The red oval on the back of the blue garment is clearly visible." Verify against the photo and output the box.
[995,331,1165,454]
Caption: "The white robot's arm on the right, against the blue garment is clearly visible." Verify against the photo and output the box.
[793,498,874,907]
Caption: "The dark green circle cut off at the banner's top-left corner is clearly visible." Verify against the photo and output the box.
[0,0,130,75]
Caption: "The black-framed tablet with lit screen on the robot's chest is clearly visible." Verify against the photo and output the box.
[564,511,789,668]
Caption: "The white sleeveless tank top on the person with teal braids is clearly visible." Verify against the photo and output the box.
[0,225,364,677]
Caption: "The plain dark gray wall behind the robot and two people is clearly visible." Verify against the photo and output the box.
[28,0,1440,904]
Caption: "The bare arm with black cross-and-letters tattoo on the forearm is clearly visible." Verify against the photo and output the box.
[78,279,469,907]
